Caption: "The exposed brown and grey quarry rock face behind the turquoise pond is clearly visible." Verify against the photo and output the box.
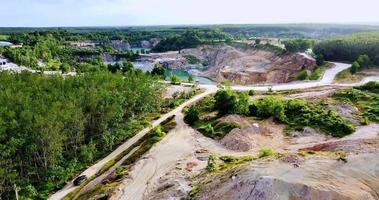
[181,45,315,85]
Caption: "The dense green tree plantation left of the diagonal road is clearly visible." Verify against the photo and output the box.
[0,71,164,199]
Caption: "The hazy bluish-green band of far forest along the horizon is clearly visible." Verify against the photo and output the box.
[0,24,379,41]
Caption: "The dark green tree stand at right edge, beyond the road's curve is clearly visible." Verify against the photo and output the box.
[313,32,379,65]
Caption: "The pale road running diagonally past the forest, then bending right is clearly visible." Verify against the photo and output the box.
[49,63,379,200]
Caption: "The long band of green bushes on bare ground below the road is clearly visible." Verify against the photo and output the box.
[187,89,356,139]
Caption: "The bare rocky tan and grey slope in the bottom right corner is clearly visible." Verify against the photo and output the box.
[198,153,379,200]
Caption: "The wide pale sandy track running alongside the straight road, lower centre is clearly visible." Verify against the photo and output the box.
[111,114,195,200]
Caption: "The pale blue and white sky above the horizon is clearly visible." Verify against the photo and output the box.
[0,0,379,27]
